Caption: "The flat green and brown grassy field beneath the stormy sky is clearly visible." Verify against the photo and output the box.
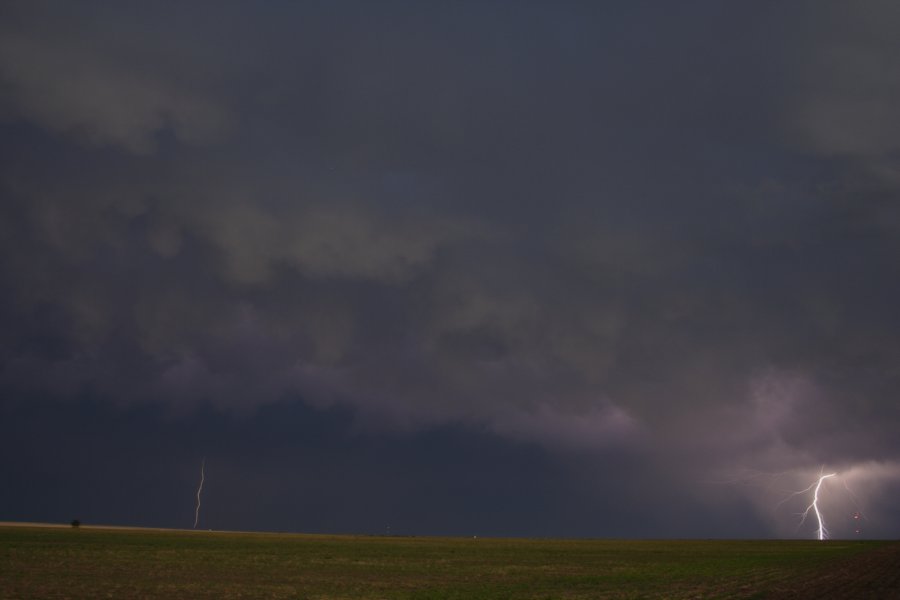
[0,526,900,599]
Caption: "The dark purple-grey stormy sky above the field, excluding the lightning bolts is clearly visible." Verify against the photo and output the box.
[0,0,900,538]
